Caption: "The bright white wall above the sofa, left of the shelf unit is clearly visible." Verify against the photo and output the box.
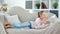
[4,0,25,9]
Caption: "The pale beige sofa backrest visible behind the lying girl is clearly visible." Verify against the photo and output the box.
[7,6,57,22]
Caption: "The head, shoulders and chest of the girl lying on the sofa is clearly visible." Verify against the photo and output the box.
[35,11,48,26]
